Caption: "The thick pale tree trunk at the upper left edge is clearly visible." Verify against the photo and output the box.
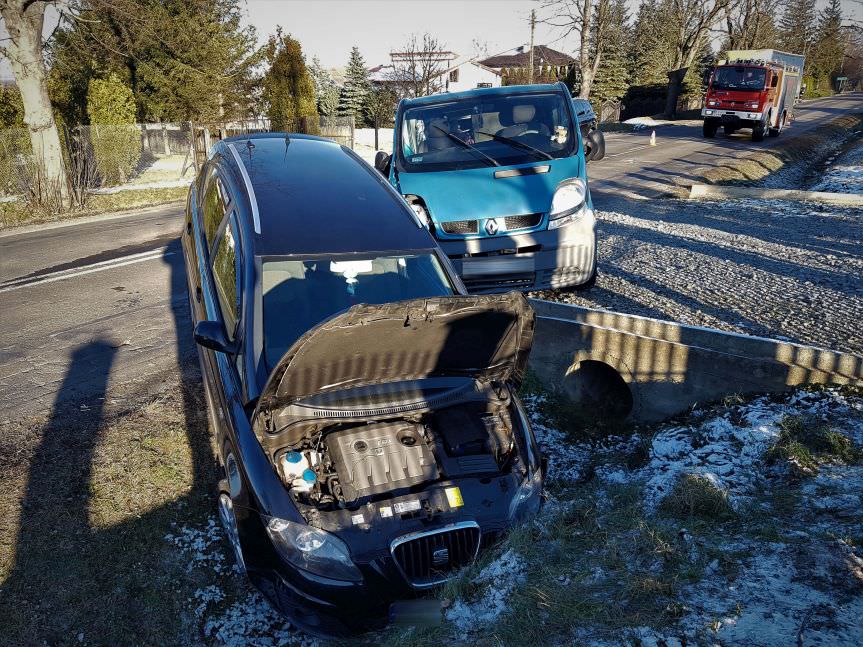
[0,0,69,208]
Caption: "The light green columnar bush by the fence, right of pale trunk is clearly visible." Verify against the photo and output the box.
[87,74,141,186]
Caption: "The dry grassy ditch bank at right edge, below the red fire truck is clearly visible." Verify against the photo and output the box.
[702,113,863,188]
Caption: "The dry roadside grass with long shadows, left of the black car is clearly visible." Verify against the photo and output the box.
[0,378,215,645]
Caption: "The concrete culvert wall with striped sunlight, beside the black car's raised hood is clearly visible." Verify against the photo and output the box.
[530,300,863,421]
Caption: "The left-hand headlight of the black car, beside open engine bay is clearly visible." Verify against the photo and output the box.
[264,517,363,582]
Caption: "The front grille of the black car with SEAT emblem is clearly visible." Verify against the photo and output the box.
[391,521,480,588]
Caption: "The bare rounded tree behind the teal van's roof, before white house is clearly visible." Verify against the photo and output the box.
[390,33,449,97]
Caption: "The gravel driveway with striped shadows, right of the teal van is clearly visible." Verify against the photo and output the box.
[531,195,863,354]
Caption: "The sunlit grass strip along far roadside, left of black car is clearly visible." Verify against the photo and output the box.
[0,187,189,229]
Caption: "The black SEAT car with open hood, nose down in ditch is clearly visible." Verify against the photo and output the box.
[182,134,544,635]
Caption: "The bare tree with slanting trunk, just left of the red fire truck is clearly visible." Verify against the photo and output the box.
[665,0,731,117]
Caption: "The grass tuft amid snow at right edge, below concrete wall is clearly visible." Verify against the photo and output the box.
[765,416,863,477]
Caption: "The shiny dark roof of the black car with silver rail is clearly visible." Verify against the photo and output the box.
[213,133,436,256]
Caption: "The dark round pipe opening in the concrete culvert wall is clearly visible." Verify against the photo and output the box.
[563,359,634,419]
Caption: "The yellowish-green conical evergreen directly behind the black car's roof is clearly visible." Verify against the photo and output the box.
[263,29,318,133]
